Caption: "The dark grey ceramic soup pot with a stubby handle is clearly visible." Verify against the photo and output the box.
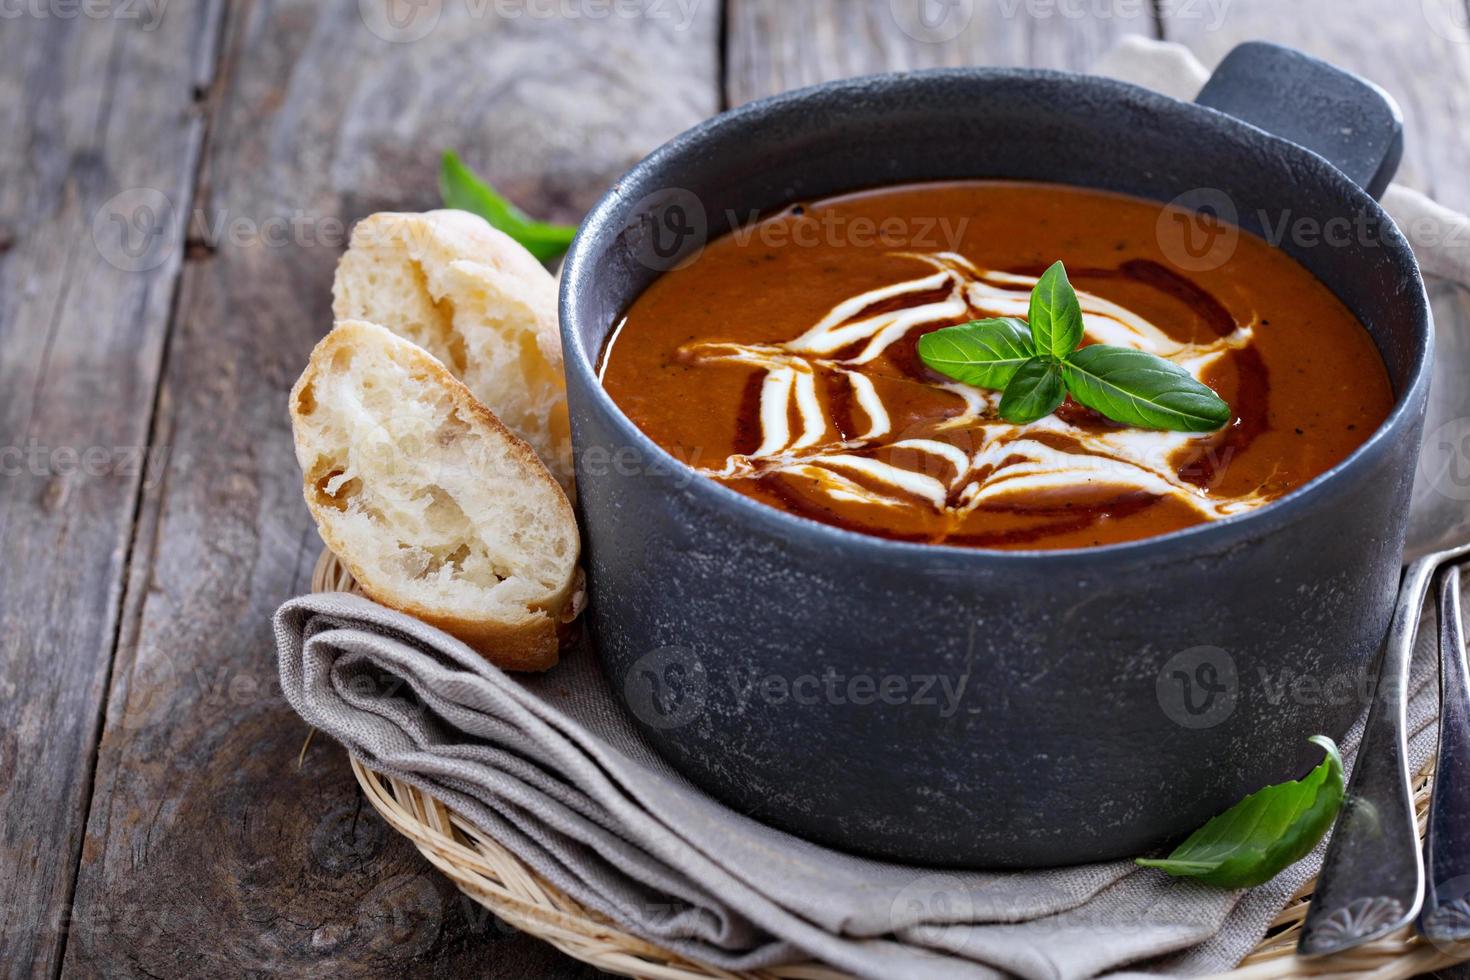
[562,46,1432,867]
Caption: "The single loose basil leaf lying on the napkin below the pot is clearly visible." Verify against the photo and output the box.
[1138,735,1344,887]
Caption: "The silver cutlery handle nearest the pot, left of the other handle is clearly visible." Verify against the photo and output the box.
[1297,554,1444,956]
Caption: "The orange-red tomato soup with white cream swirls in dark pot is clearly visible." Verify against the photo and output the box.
[598,181,1394,550]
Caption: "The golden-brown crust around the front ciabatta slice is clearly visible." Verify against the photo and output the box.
[290,320,581,671]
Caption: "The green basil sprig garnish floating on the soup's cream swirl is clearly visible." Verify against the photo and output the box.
[919,262,1230,432]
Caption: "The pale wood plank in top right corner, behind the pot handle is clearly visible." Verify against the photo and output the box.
[1163,0,1470,210]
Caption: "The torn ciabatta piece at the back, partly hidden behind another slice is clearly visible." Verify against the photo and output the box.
[332,210,572,489]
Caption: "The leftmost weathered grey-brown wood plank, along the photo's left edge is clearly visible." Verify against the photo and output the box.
[0,3,219,977]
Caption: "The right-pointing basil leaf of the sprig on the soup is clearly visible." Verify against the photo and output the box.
[1063,344,1230,432]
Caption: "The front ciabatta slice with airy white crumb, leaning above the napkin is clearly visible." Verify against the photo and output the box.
[291,320,581,670]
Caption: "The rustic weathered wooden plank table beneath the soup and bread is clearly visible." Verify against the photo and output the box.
[0,0,1470,977]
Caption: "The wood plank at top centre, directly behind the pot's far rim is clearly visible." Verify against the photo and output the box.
[726,0,1155,104]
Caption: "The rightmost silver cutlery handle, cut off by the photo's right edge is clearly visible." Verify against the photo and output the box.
[1419,567,1470,943]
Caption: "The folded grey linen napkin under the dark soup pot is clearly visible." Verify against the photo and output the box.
[275,594,1438,979]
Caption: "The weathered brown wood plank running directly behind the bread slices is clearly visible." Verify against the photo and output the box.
[66,0,719,977]
